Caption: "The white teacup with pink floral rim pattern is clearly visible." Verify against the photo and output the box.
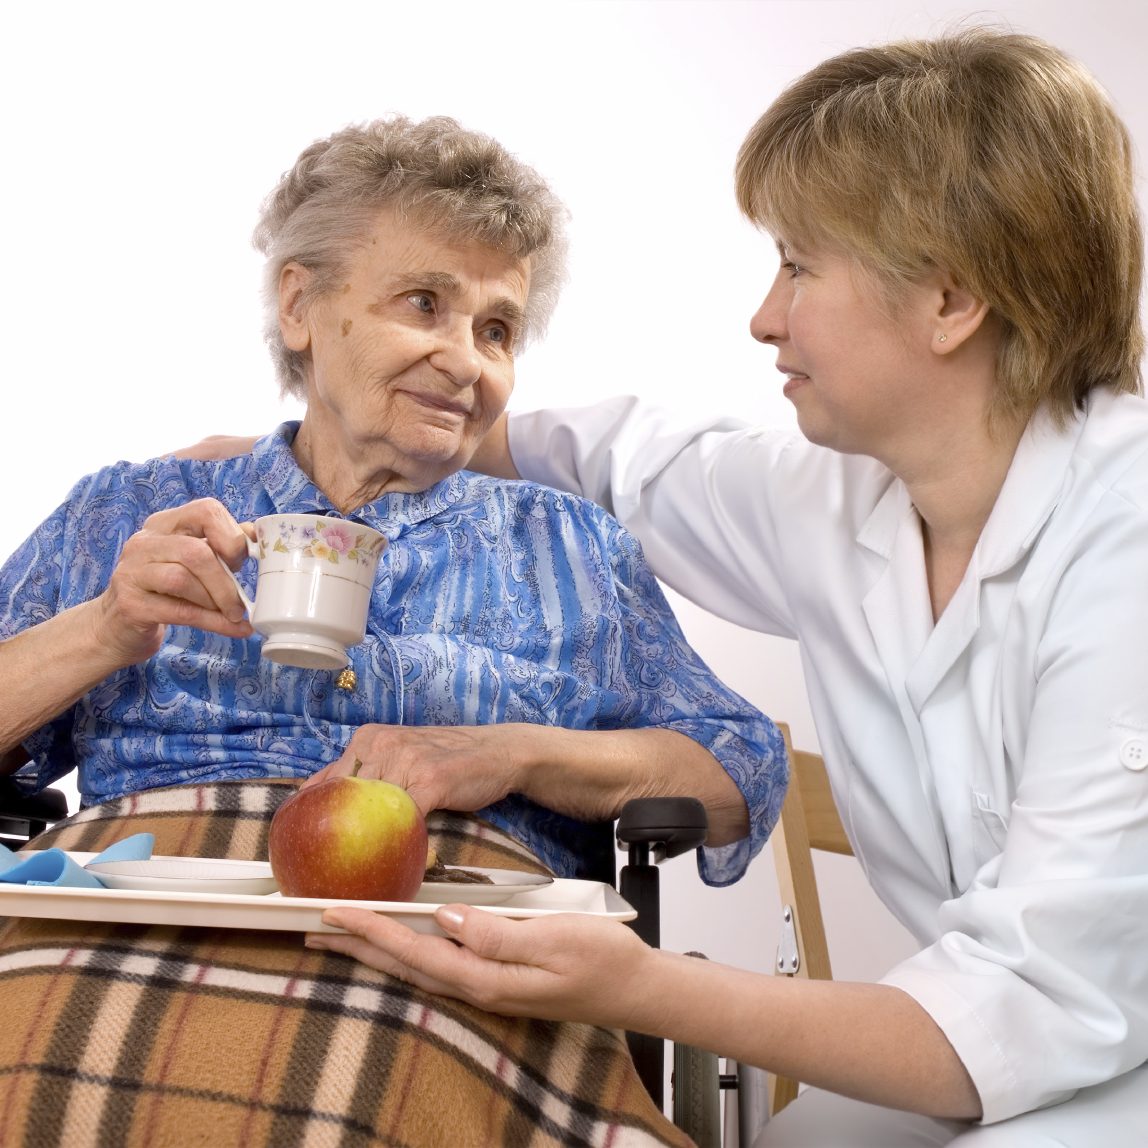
[220,514,387,669]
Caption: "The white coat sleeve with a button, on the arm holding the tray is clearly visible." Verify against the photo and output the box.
[884,467,1148,1123]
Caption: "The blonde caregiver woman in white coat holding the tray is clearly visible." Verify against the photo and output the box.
[312,30,1148,1148]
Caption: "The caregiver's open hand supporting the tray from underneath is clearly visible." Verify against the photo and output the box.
[307,905,654,1027]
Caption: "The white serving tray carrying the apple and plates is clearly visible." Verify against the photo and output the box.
[0,853,637,934]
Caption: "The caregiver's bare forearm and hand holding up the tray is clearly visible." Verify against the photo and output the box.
[308,906,980,1119]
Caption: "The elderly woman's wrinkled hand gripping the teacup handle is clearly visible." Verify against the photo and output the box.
[93,498,251,666]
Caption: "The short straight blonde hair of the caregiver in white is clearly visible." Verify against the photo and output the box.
[736,29,1143,424]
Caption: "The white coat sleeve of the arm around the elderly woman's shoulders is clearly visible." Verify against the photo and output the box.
[509,396,794,637]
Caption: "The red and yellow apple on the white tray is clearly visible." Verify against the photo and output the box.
[267,775,427,901]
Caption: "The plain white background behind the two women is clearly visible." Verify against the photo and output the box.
[0,0,1148,1005]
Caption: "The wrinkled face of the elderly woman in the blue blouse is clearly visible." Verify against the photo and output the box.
[280,211,529,492]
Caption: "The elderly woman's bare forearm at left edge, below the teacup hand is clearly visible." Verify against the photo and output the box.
[0,603,129,754]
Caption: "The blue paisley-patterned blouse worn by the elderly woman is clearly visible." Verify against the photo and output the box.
[0,422,786,885]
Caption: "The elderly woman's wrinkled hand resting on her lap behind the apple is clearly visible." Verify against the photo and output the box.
[304,724,527,814]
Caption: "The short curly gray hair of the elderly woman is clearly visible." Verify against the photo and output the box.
[253,116,567,398]
